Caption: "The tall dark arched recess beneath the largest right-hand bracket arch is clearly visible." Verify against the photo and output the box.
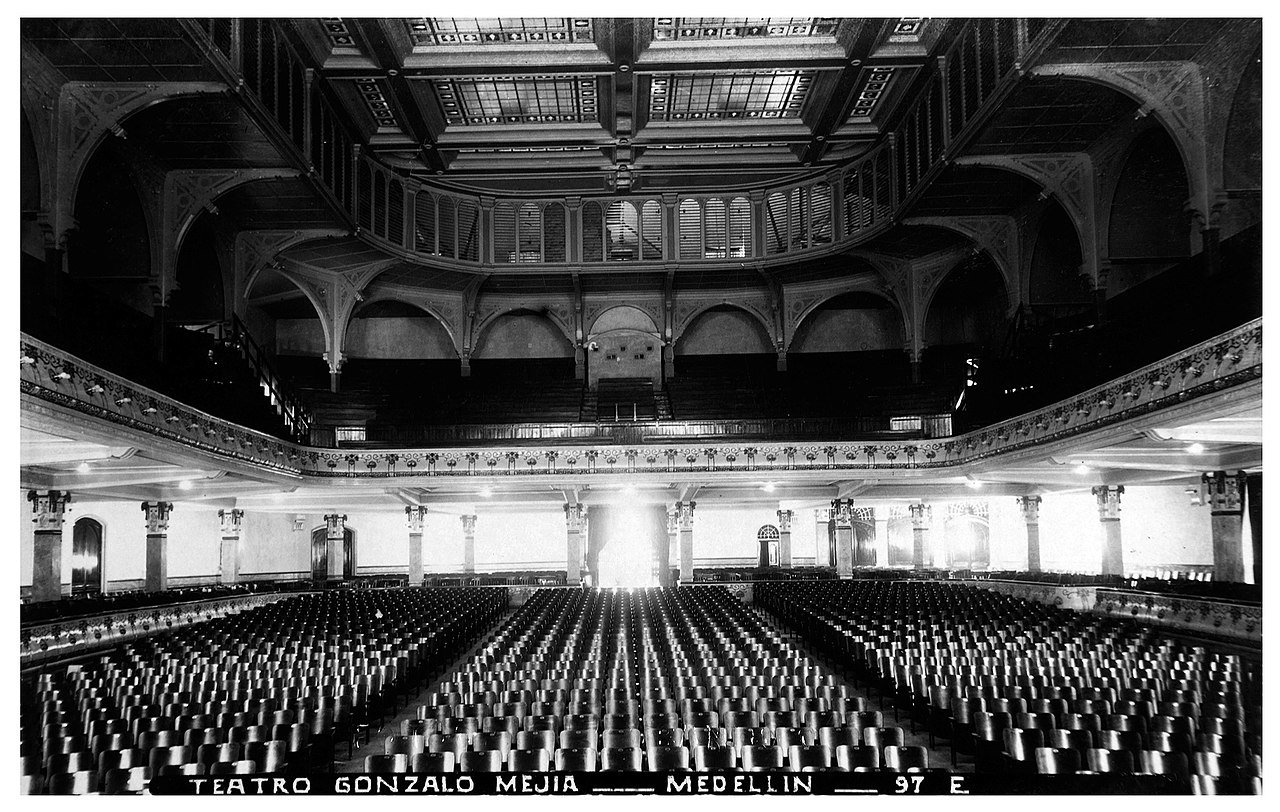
[1105,127,1190,259]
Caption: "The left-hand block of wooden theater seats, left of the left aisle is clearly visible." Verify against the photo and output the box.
[20,589,507,794]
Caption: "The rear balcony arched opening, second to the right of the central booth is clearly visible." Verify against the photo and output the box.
[787,291,910,386]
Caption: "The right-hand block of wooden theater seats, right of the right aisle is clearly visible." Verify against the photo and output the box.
[754,581,1262,794]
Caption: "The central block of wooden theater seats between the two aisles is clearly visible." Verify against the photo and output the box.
[365,587,929,772]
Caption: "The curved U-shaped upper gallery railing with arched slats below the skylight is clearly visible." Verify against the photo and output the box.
[188,18,1052,269]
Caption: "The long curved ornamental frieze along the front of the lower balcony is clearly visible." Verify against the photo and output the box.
[20,319,1262,479]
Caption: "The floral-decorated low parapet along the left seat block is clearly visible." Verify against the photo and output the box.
[18,593,294,667]
